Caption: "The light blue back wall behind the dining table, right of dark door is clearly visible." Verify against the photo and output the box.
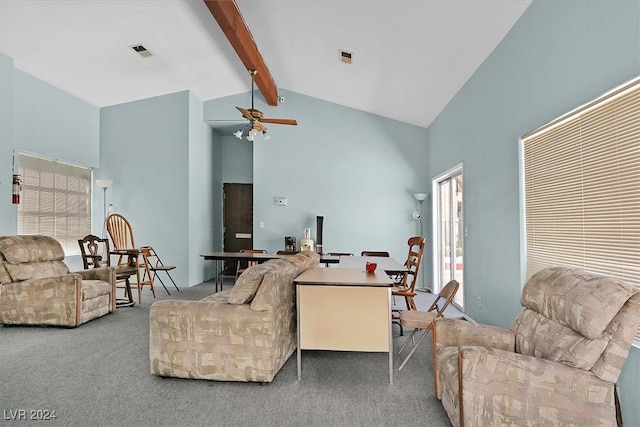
[205,89,428,266]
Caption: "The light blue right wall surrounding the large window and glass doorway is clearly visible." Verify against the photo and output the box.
[426,0,640,425]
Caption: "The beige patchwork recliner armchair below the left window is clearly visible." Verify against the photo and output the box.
[0,236,116,327]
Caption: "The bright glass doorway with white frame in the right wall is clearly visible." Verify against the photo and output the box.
[432,164,465,312]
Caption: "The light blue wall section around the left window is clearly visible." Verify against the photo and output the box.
[0,55,102,270]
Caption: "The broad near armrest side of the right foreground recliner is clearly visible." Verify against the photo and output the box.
[452,346,615,425]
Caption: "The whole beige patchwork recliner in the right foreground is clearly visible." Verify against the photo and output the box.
[433,267,640,426]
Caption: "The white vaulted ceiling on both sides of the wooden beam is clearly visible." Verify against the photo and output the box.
[0,0,530,127]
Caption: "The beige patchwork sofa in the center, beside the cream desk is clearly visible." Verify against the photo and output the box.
[149,252,320,383]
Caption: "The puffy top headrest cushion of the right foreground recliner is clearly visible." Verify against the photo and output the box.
[521,267,636,340]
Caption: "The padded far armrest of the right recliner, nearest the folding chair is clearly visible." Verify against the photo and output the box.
[433,318,516,351]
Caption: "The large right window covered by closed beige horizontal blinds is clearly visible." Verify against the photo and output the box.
[522,79,640,344]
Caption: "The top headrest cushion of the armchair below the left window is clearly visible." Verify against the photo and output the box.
[0,236,64,264]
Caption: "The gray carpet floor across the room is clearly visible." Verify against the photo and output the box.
[0,283,450,427]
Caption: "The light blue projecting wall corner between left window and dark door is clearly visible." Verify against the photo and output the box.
[97,91,220,292]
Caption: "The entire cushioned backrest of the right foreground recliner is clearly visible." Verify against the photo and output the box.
[511,267,640,382]
